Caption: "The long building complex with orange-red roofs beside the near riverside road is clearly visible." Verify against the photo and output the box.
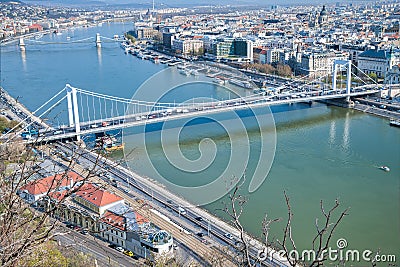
[20,172,173,257]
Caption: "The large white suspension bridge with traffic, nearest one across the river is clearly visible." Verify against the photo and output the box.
[2,60,382,142]
